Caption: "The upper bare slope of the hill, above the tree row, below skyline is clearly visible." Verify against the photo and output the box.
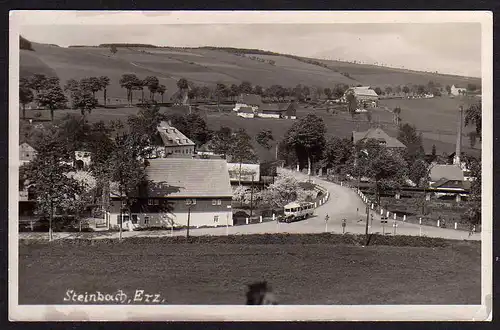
[20,43,480,100]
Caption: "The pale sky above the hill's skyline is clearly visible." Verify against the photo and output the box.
[20,13,481,77]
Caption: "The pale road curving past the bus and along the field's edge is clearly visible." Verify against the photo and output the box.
[20,169,481,240]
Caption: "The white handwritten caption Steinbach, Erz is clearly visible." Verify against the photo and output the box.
[63,289,165,304]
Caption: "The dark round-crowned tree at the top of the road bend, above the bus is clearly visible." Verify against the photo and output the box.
[284,114,326,172]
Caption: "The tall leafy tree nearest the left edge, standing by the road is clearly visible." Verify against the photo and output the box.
[20,128,82,241]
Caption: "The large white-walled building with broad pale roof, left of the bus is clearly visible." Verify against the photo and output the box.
[107,158,233,230]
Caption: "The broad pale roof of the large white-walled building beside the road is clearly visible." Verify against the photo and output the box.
[146,158,232,197]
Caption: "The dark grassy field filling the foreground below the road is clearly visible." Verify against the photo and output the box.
[19,238,481,304]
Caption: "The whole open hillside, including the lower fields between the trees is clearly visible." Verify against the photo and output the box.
[20,43,480,159]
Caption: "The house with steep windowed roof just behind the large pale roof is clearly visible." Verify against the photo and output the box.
[152,121,195,158]
